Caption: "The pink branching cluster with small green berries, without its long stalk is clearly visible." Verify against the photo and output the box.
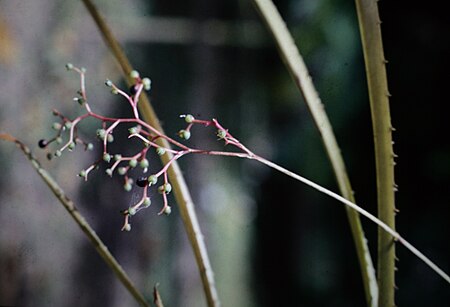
[38,63,257,231]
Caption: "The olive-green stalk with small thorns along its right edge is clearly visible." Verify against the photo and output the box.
[356,0,395,306]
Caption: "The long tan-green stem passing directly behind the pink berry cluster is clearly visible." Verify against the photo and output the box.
[83,0,220,306]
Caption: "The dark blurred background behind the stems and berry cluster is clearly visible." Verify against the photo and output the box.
[0,0,450,306]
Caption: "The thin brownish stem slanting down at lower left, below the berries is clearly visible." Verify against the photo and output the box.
[0,134,150,306]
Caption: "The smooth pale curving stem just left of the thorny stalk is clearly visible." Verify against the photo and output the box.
[253,0,378,306]
